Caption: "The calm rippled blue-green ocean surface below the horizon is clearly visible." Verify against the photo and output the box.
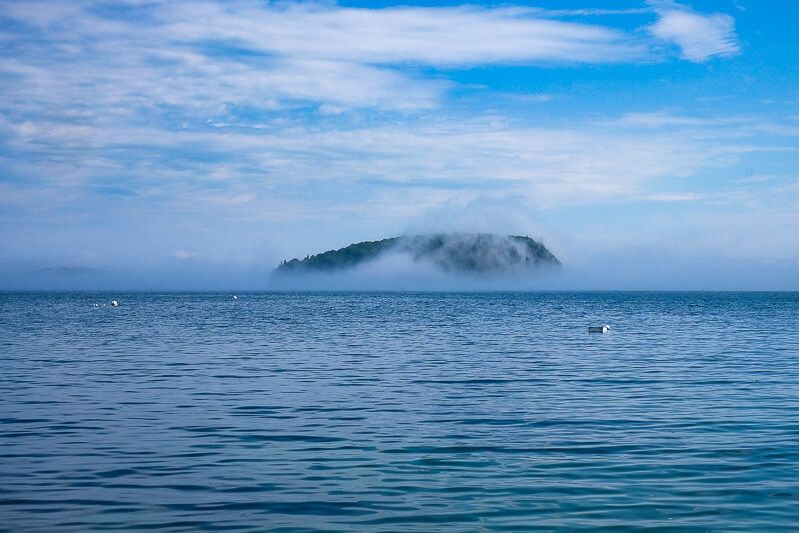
[0,293,799,532]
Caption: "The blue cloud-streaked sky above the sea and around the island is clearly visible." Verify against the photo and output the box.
[0,0,799,290]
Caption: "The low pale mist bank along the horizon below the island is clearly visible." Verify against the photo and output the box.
[6,249,799,291]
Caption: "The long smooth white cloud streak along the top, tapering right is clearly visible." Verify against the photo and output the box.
[161,2,646,65]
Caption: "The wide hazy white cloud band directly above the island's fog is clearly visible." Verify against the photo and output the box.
[1,110,780,214]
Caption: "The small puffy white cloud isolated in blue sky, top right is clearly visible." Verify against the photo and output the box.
[649,3,740,62]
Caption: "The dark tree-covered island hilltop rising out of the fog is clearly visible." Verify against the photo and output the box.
[275,233,560,274]
